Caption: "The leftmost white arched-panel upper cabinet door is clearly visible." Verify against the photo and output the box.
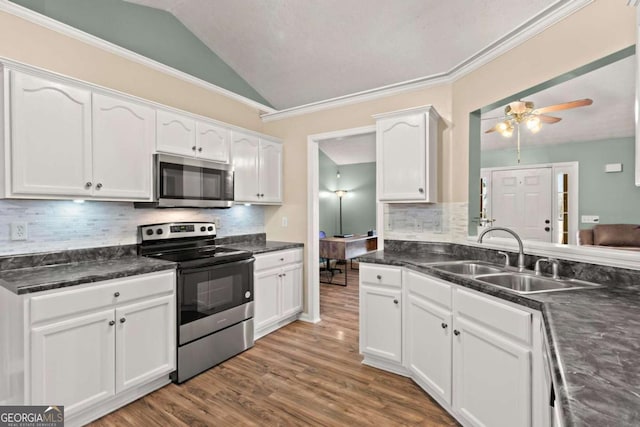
[10,71,92,197]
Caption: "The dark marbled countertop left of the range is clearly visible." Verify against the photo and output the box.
[0,255,176,295]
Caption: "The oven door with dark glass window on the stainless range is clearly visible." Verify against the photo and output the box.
[178,258,255,345]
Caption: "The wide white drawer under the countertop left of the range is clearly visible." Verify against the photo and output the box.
[31,271,176,323]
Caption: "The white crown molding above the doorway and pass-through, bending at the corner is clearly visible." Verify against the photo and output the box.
[261,0,596,122]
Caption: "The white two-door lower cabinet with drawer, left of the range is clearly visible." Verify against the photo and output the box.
[25,270,176,425]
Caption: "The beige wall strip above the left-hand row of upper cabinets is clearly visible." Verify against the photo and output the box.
[0,12,262,131]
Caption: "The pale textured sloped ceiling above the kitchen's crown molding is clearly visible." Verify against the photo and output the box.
[128,0,566,109]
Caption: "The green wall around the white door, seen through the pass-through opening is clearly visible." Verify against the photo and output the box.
[482,137,640,228]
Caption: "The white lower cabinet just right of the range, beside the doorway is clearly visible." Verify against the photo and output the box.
[253,249,302,339]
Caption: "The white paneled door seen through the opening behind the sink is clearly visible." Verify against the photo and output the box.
[491,167,553,242]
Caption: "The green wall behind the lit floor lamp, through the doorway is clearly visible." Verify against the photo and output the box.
[319,150,376,236]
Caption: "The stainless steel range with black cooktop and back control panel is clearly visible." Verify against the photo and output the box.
[138,222,255,383]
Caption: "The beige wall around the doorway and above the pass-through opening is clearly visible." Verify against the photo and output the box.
[264,0,635,242]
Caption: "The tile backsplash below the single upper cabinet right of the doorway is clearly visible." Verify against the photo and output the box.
[384,202,468,242]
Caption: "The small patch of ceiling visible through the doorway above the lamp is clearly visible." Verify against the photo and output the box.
[318,133,376,166]
